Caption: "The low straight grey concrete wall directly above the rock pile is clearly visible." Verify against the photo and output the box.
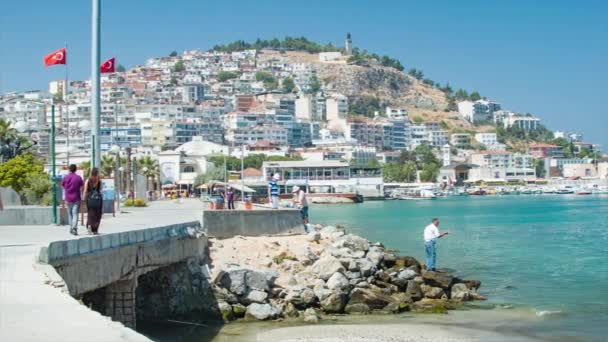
[202,209,304,238]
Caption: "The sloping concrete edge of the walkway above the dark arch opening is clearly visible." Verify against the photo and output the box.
[39,221,200,264]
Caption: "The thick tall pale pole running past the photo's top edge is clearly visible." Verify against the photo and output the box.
[91,0,101,167]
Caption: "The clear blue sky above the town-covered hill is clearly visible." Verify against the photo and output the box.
[0,0,608,151]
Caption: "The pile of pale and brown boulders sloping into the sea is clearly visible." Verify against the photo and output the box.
[212,226,485,322]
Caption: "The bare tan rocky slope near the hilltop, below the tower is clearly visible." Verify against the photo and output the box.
[258,50,476,131]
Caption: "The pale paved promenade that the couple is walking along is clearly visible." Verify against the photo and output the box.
[0,199,204,342]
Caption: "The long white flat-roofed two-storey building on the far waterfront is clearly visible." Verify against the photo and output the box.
[262,160,384,198]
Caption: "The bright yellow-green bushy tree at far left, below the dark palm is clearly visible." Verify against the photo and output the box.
[0,154,43,193]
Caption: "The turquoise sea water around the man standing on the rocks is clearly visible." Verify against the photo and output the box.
[310,195,608,341]
